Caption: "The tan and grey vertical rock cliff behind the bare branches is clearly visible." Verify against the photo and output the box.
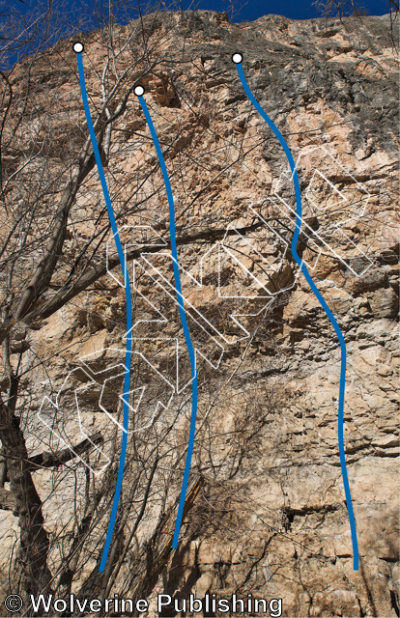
[0,11,399,617]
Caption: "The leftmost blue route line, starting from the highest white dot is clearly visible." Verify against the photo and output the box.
[76,52,133,573]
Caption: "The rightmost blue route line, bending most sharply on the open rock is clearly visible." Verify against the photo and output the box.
[234,60,358,571]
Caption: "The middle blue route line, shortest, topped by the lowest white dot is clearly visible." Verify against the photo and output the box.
[138,96,198,549]
